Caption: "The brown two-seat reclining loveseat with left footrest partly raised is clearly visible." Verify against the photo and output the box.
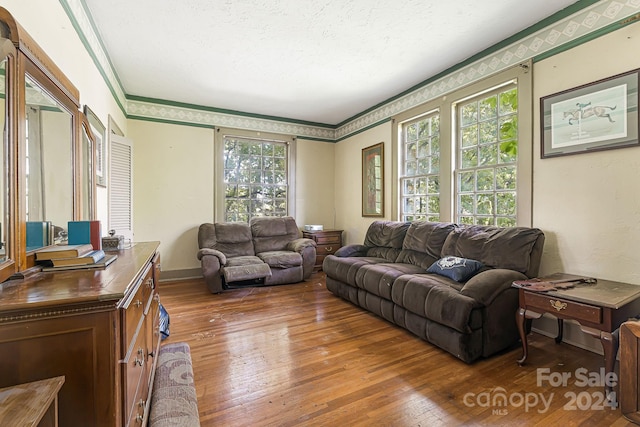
[198,217,316,293]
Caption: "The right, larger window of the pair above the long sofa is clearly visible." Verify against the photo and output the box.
[455,83,518,227]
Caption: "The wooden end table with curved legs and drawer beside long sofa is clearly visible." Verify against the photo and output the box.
[516,273,640,396]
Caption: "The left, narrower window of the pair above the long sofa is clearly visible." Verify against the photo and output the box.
[400,112,440,221]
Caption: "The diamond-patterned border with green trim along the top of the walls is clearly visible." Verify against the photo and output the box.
[60,0,640,142]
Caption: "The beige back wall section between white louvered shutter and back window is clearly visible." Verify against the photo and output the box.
[127,120,213,271]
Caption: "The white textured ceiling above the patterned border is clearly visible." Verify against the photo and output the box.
[85,0,576,124]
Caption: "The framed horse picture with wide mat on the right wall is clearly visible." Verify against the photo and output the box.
[540,69,640,158]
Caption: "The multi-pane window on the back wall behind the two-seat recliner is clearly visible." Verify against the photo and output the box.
[218,131,292,222]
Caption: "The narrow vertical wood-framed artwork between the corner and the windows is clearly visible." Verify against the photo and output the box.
[362,142,384,217]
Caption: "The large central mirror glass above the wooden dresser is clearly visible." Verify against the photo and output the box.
[25,74,74,251]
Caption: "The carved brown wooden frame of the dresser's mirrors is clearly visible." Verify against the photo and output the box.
[0,7,90,276]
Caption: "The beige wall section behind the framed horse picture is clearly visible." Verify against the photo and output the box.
[533,24,640,284]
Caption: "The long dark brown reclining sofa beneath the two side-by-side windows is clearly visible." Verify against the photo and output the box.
[323,221,544,363]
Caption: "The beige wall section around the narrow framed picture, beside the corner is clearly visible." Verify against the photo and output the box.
[335,122,392,244]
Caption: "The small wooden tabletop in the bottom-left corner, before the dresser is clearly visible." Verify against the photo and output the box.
[0,377,64,427]
